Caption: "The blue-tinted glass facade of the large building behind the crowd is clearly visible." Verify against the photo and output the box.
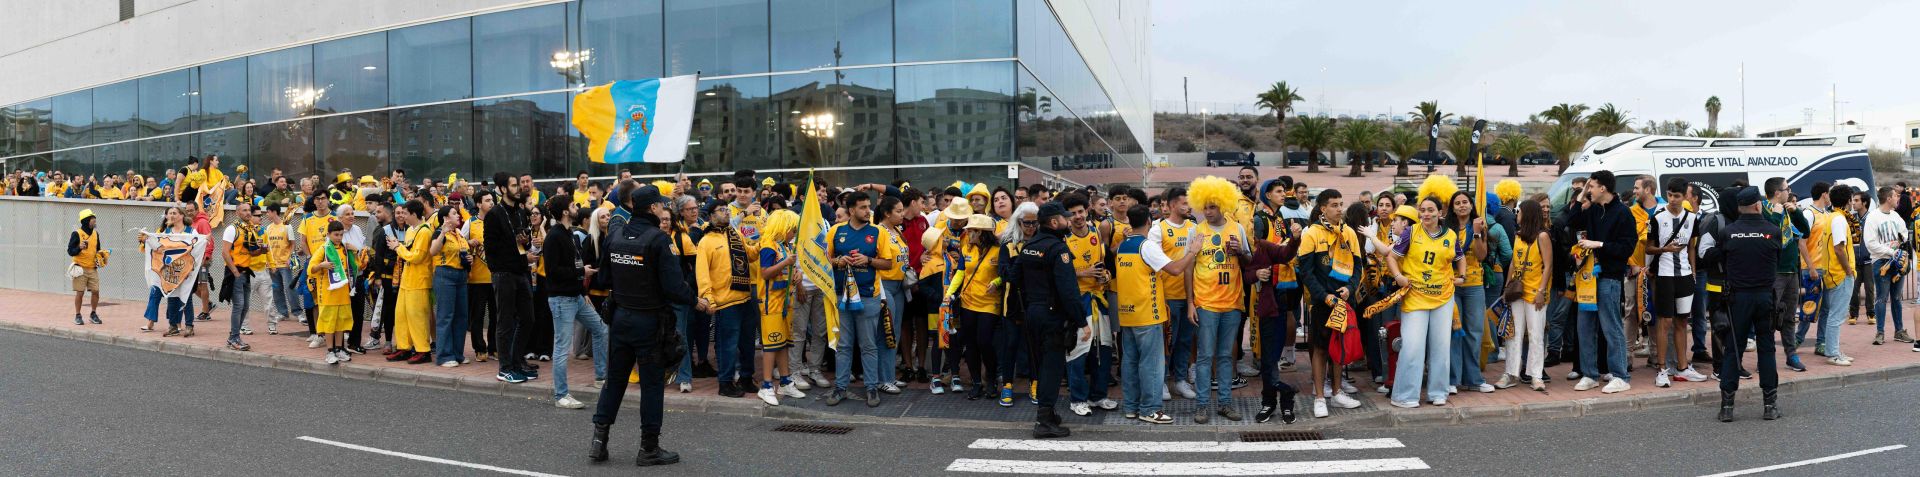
[0,0,1142,185]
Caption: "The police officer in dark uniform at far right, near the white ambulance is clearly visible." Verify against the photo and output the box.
[1701,187,1782,423]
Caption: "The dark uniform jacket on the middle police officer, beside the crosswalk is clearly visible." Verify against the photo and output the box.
[1014,231,1087,331]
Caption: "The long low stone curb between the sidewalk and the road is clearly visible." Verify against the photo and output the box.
[0,321,1920,432]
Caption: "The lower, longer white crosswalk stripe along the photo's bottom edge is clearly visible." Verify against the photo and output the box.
[947,458,1430,475]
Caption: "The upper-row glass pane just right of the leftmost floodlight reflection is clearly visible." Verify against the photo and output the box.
[313,31,386,113]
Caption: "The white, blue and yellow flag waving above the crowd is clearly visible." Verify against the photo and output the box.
[574,75,699,163]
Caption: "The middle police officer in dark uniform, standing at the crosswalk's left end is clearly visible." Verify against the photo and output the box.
[1014,202,1087,439]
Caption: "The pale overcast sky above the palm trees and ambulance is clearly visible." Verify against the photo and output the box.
[1152,0,1920,141]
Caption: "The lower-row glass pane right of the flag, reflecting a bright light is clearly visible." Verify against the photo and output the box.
[774,67,895,183]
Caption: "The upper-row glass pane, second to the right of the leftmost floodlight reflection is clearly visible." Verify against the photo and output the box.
[386,17,474,106]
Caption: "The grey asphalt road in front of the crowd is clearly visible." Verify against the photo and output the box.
[0,331,1920,475]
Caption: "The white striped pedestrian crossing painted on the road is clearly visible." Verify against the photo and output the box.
[947,439,1432,475]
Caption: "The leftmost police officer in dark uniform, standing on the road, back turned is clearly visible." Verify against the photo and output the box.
[588,185,693,465]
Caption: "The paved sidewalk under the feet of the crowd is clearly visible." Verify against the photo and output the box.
[0,289,1920,431]
